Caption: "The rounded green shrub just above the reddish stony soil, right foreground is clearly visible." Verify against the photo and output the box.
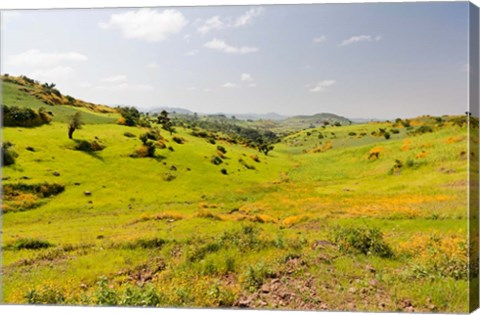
[331,226,393,258]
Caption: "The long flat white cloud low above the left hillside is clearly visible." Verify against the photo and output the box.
[6,49,88,68]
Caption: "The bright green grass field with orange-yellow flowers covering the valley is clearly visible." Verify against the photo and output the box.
[2,79,468,312]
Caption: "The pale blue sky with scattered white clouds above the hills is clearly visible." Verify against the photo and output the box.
[0,2,468,119]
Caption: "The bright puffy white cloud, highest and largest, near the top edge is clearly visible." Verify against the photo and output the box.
[99,8,188,42]
